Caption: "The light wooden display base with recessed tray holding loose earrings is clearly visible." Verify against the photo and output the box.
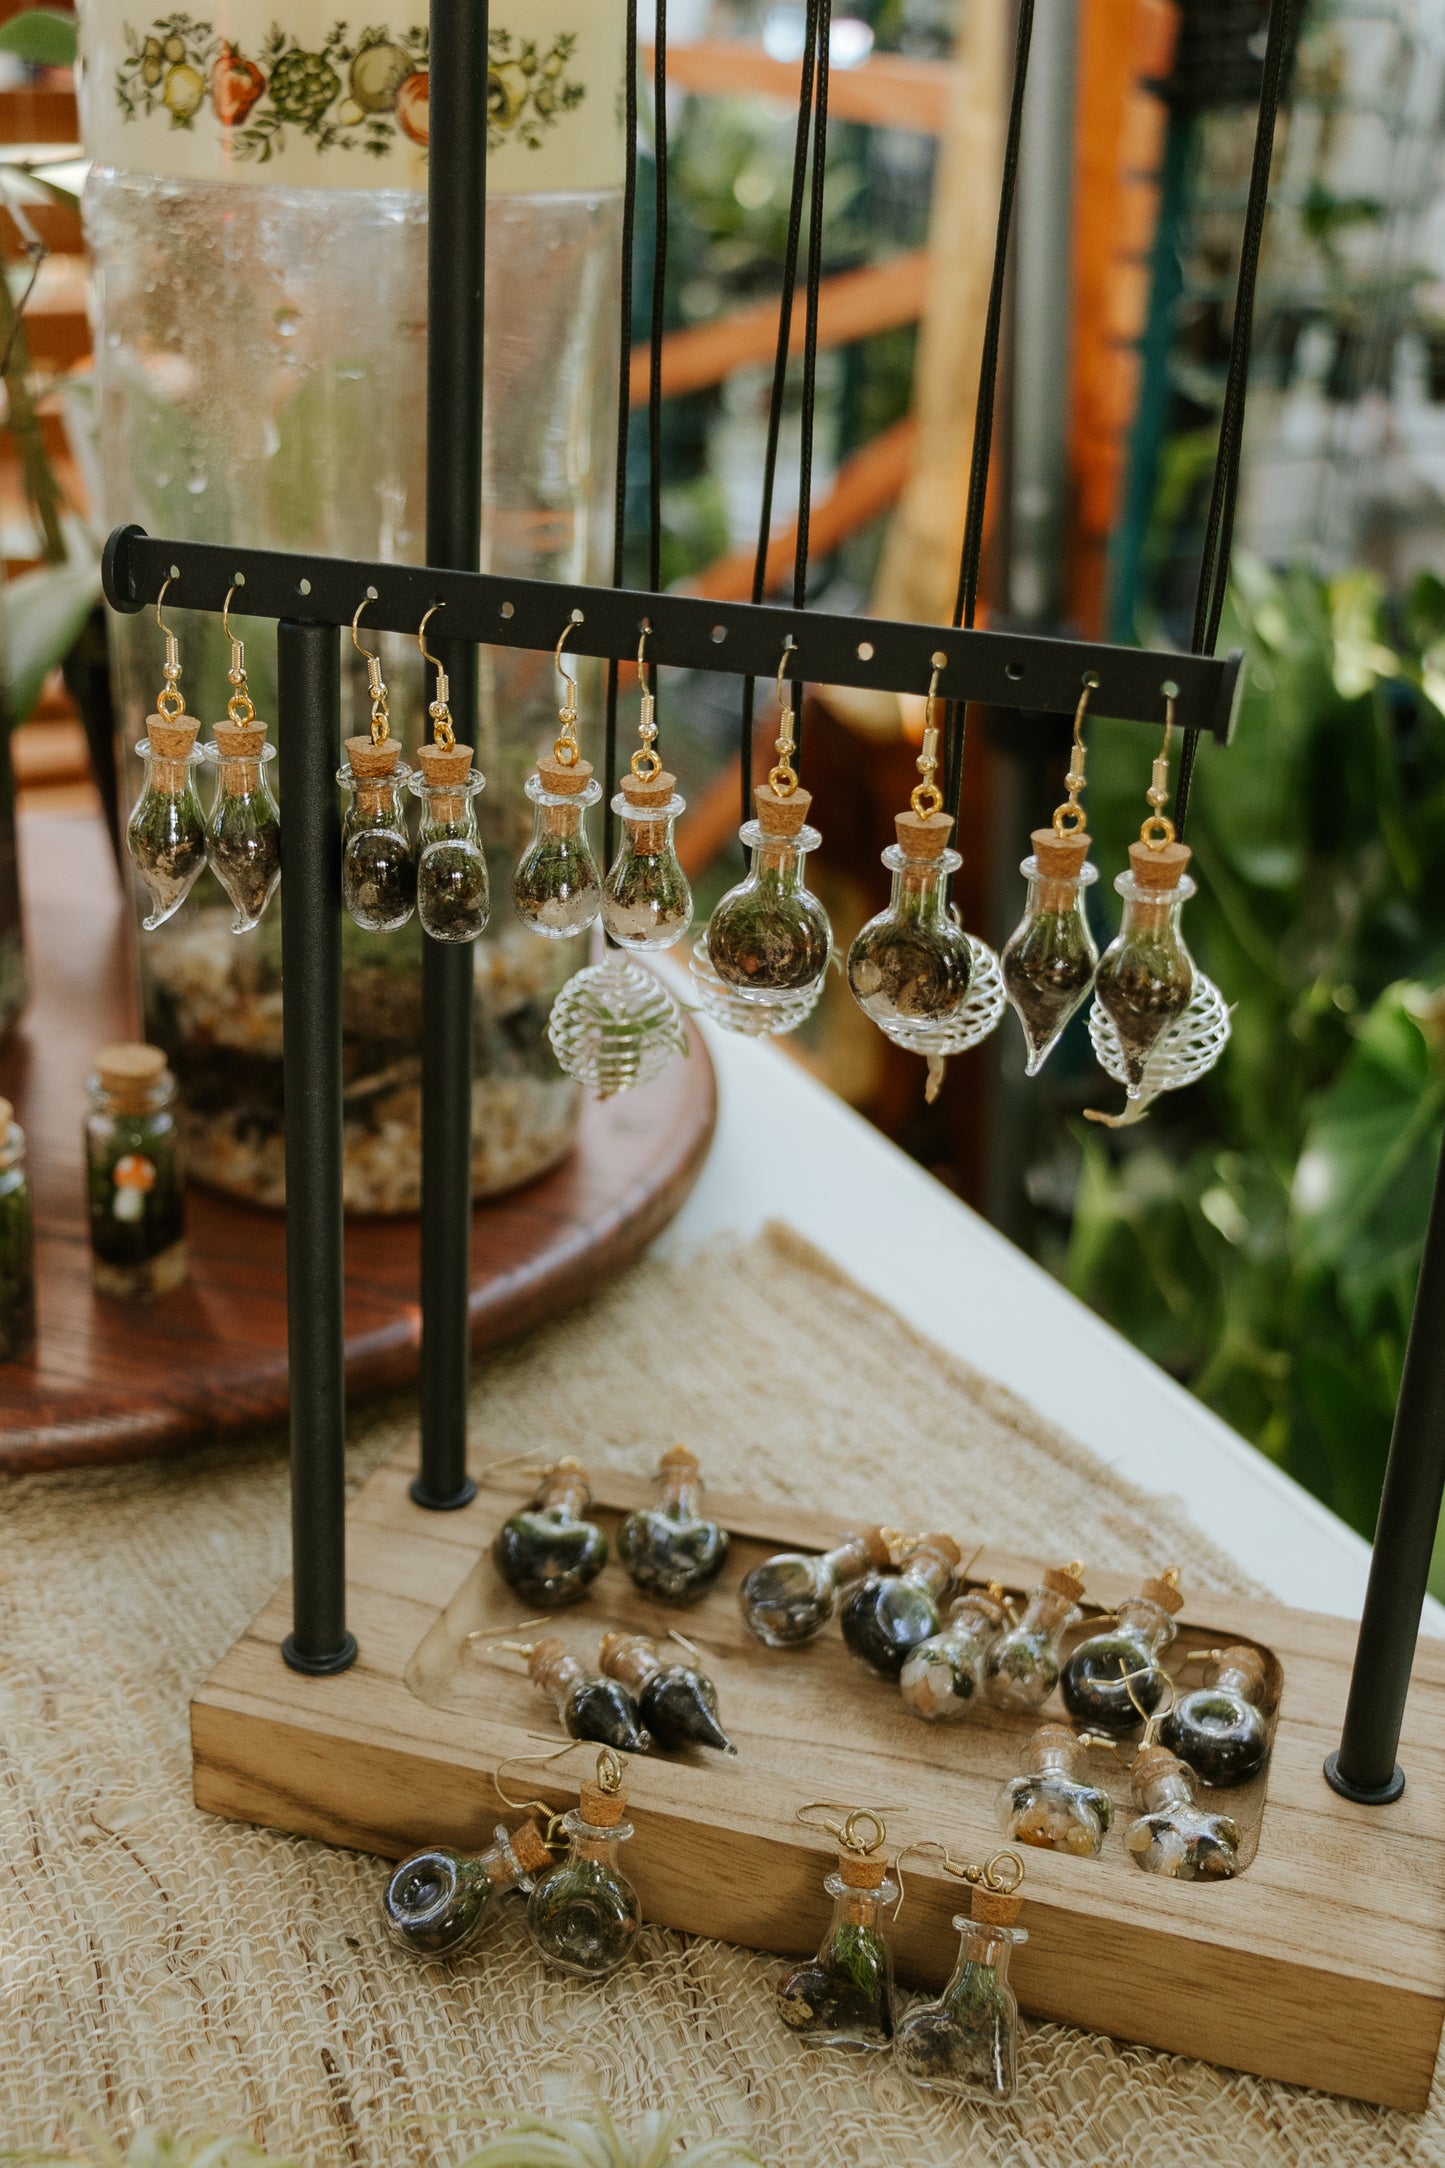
[191,1455,1445,2109]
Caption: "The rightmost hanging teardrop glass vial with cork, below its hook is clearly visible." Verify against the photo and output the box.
[1094,843,1194,1099]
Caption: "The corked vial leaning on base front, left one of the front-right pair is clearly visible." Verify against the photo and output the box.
[778,1851,899,2049]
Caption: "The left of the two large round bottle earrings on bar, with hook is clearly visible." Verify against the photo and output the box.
[691,648,832,1036]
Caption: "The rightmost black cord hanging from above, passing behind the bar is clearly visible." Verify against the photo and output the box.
[1174,0,1293,839]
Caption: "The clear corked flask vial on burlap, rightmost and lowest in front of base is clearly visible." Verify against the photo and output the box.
[895,1888,1029,2105]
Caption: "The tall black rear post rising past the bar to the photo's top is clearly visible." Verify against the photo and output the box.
[412,0,487,1513]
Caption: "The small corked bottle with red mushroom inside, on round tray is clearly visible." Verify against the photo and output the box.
[84,1045,186,1296]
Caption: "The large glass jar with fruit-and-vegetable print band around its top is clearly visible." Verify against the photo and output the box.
[80,0,626,1212]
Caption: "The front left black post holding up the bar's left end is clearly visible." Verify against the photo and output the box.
[277,622,355,1672]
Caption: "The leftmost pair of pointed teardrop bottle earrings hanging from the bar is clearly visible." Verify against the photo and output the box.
[126,579,282,934]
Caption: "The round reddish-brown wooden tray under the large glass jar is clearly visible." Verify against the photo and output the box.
[0,813,717,1474]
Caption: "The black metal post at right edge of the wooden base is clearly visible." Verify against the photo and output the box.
[1324,1149,1445,1806]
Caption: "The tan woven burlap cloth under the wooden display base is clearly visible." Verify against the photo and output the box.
[0,1229,1445,2168]
